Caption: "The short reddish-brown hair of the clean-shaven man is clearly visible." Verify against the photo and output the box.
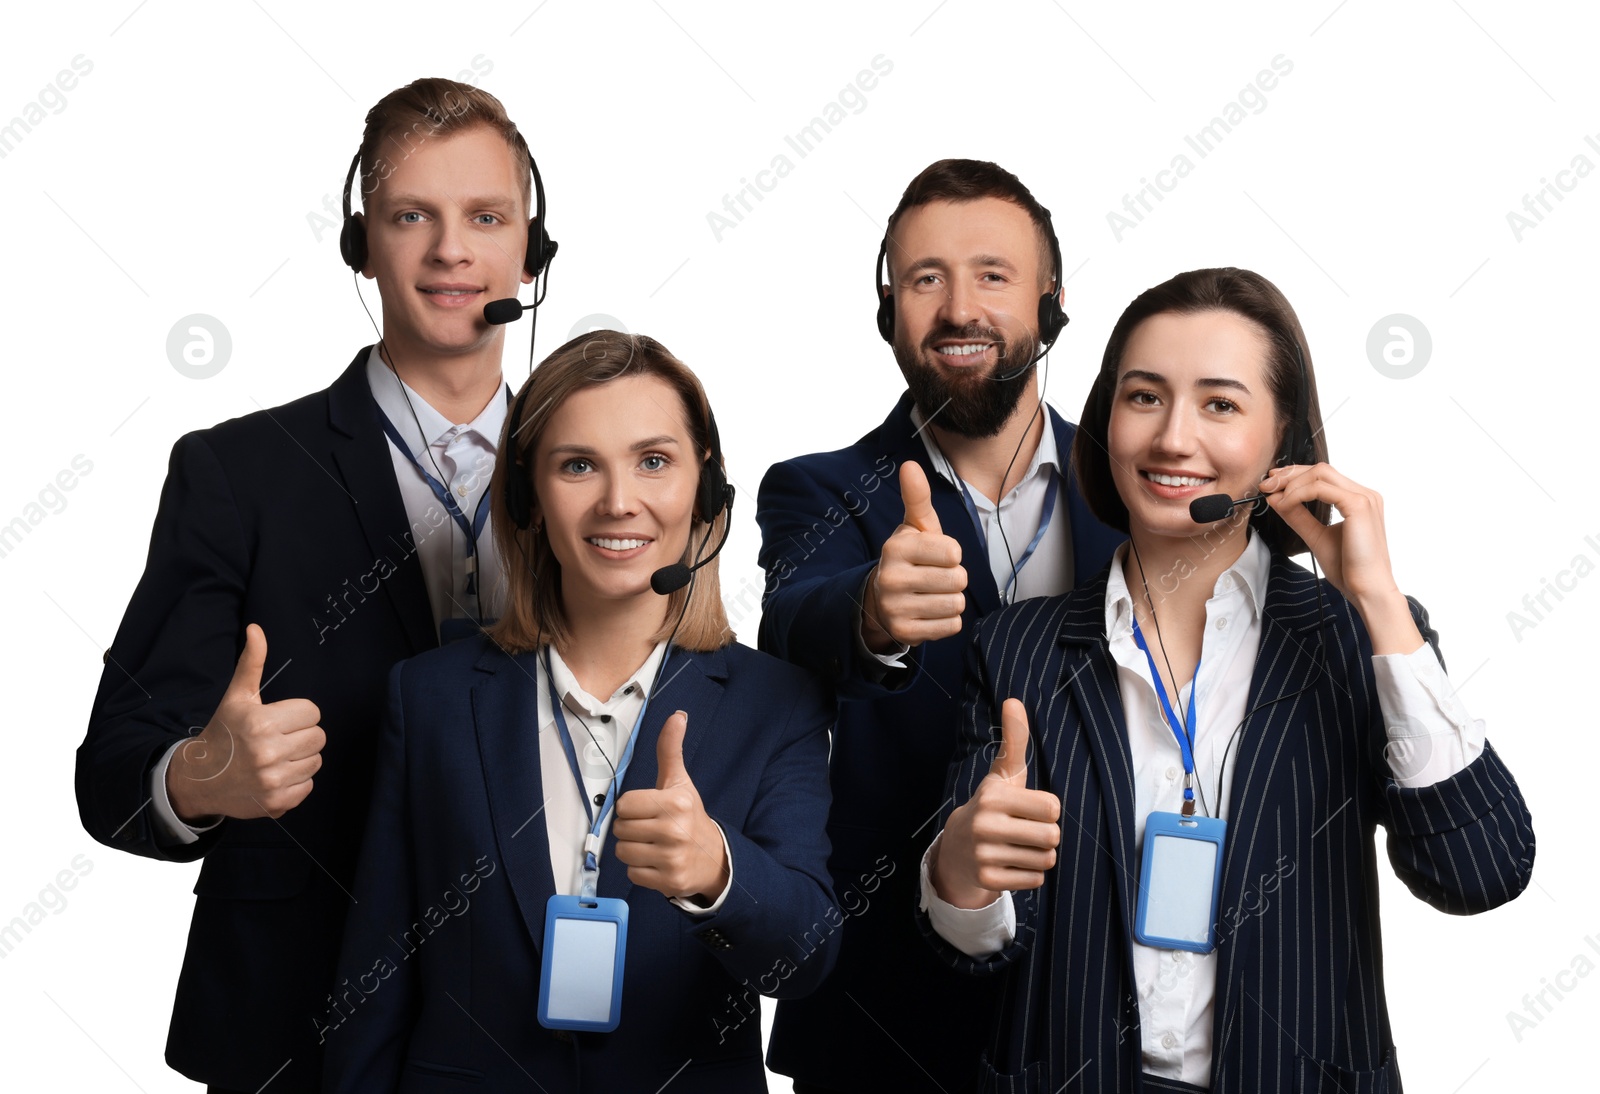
[358,77,533,218]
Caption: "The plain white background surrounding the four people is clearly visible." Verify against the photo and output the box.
[0,0,1600,1094]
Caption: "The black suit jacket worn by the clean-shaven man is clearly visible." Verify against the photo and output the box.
[77,349,437,1094]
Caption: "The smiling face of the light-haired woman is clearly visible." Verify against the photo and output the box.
[533,374,699,617]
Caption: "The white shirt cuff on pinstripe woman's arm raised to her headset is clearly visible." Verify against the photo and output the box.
[1373,641,1485,790]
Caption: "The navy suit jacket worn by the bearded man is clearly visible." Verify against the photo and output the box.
[755,393,1123,1091]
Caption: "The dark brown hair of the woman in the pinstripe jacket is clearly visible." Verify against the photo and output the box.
[1072,266,1331,555]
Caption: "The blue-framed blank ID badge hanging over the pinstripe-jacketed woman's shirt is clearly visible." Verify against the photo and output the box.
[1133,813,1227,953]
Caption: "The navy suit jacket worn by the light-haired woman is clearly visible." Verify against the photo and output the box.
[326,638,842,1094]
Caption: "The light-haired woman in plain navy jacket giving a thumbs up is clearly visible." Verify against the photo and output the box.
[331,331,842,1094]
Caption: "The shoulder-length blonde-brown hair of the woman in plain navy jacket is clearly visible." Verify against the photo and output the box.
[490,331,734,653]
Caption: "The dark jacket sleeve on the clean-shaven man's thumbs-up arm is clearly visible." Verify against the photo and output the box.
[74,433,248,862]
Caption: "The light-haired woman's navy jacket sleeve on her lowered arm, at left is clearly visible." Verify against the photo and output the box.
[317,662,416,1094]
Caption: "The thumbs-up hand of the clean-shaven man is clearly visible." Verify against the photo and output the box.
[166,624,328,824]
